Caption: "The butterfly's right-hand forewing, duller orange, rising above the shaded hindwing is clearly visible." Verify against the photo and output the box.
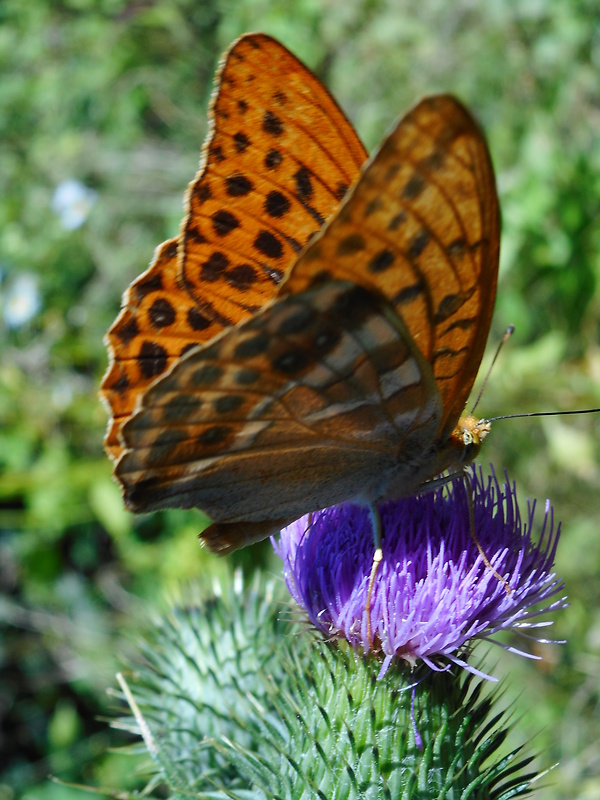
[280,95,499,434]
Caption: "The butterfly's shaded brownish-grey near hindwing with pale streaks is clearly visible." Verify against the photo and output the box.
[117,281,441,522]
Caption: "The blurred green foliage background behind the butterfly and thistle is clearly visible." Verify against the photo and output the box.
[0,0,600,800]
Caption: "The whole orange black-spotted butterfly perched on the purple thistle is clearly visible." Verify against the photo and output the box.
[101,34,499,553]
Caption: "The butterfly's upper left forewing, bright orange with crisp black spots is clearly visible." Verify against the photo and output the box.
[183,34,366,310]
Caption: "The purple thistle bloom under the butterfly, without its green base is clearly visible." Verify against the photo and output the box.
[274,469,566,678]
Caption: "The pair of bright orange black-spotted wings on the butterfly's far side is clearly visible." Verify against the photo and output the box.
[102,34,366,459]
